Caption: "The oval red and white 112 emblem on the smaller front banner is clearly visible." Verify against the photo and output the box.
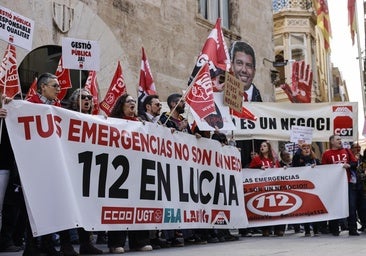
[247,191,302,216]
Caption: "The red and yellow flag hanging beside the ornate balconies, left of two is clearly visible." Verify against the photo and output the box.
[314,0,332,51]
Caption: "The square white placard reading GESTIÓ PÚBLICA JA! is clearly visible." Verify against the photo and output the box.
[62,37,100,71]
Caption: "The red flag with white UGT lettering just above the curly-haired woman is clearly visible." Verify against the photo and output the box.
[100,61,126,116]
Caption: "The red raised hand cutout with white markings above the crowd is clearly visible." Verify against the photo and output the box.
[281,61,313,103]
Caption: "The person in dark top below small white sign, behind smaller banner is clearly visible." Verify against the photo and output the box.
[292,143,320,236]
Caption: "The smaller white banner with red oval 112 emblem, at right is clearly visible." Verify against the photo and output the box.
[242,164,348,227]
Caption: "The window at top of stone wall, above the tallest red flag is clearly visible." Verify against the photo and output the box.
[199,0,229,29]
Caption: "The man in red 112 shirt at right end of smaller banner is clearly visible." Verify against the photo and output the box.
[322,135,364,236]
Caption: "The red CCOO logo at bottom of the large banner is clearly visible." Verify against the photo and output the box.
[102,207,135,224]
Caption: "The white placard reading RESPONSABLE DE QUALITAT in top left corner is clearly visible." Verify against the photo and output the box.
[0,5,34,51]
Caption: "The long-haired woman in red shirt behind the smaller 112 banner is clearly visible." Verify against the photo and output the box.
[249,141,285,236]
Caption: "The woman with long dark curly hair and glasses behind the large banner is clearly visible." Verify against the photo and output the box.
[108,94,153,253]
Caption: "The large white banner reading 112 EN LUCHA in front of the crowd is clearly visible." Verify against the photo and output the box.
[6,100,248,236]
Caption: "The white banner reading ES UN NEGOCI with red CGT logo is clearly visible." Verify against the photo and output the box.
[234,102,358,142]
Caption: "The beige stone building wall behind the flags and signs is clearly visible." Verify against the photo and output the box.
[0,0,274,104]
